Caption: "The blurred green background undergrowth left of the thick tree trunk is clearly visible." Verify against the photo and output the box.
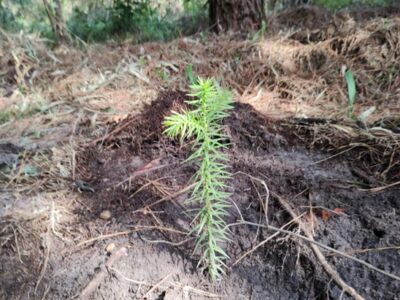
[0,0,207,42]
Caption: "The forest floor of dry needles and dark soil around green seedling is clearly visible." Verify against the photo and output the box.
[0,8,400,300]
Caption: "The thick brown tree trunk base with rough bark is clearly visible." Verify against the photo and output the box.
[209,0,265,32]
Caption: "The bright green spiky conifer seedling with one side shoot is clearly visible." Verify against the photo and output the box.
[164,78,233,281]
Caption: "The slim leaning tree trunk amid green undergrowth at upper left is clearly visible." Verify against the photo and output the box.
[43,0,72,44]
